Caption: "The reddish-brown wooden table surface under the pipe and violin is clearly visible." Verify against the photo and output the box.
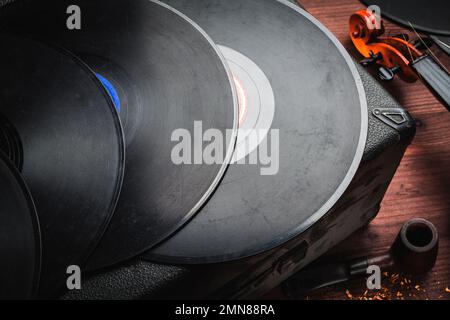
[271,0,450,300]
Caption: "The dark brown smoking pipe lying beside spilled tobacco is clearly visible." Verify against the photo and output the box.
[282,219,439,296]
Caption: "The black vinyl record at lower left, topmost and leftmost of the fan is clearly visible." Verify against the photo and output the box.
[0,151,41,300]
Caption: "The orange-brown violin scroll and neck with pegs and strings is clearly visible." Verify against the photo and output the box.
[349,10,450,111]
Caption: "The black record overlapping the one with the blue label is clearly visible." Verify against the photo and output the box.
[0,35,124,295]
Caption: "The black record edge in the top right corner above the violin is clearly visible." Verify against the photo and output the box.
[361,0,450,35]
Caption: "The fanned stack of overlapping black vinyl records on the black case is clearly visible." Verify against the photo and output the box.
[0,0,368,298]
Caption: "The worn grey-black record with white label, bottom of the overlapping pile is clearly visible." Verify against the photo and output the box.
[149,0,368,263]
